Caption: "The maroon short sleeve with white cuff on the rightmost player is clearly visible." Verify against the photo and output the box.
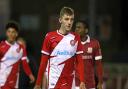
[94,41,102,60]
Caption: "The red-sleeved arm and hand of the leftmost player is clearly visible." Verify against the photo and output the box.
[21,46,35,82]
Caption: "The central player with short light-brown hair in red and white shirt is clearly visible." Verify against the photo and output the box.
[34,7,86,89]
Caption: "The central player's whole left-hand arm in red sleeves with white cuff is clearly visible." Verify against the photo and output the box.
[34,34,50,89]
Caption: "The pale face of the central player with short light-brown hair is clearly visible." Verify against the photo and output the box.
[60,14,74,31]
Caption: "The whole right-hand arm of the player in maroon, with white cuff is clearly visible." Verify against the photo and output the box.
[95,41,103,89]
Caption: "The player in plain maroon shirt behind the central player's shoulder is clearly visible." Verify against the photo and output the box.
[75,21,103,89]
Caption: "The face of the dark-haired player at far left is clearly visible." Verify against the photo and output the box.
[6,28,18,42]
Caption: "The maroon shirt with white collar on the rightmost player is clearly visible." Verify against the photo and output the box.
[76,36,103,89]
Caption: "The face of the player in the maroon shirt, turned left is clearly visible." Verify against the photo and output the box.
[75,22,88,36]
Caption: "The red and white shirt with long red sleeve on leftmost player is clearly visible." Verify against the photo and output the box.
[0,41,31,89]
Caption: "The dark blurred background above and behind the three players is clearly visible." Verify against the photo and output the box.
[0,0,128,89]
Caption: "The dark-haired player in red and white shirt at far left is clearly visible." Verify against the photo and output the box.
[0,21,35,89]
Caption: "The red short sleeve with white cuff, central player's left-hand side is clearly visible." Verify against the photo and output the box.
[41,34,50,55]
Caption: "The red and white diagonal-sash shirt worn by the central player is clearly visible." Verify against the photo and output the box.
[37,30,84,89]
